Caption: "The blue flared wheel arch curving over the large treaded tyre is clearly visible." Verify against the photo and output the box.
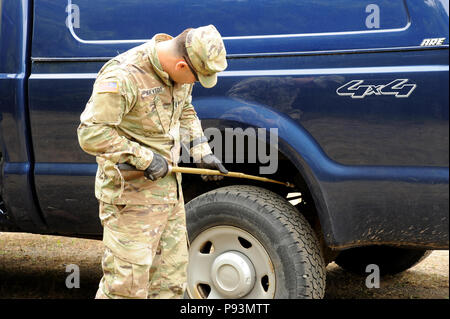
[192,97,333,244]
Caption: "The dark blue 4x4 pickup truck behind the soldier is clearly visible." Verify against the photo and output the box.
[0,0,449,298]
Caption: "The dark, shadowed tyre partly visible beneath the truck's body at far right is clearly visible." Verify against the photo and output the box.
[335,246,432,275]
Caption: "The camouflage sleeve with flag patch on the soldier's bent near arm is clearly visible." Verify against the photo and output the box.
[77,70,153,170]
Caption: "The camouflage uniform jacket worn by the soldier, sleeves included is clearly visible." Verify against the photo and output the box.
[77,34,211,205]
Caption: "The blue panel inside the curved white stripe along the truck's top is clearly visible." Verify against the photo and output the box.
[72,0,408,41]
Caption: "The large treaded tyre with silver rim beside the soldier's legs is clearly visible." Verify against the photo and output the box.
[186,185,326,299]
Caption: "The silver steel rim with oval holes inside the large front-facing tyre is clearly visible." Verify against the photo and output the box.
[187,225,276,299]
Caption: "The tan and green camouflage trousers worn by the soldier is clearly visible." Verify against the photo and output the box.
[95,197,188,299]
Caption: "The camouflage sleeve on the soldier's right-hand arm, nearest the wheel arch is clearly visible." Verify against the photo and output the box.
[180,87,212,162]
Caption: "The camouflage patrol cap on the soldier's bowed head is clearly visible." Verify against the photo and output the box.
[186,24,227,88]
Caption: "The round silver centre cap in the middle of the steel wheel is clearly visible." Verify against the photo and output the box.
[211,251,255,298]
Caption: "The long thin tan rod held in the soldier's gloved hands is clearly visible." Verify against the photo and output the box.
[118,164,294,188]
